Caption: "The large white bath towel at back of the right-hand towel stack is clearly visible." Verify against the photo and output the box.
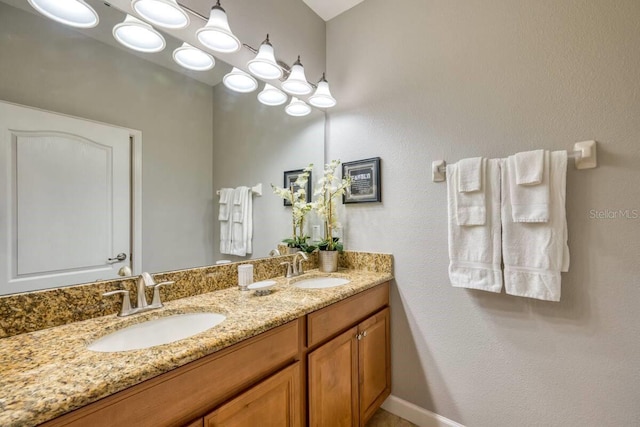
[502,151,569,301]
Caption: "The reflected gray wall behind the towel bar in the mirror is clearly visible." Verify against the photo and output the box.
[213,85,325,260]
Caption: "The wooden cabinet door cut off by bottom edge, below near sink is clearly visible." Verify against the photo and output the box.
[204,363,302,427]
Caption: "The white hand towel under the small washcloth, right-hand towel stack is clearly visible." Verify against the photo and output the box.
[502,151,549,222]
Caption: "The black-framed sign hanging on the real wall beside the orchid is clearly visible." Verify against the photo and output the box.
[342,157,382,203]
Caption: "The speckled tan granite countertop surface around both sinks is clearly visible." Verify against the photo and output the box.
[0,270,393,427]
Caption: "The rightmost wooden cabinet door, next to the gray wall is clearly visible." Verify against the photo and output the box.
[357,308,391,426]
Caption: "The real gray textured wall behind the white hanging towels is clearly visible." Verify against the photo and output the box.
[327,0,640,427]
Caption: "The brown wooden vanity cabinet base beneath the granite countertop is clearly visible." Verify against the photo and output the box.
[44,283,391,427]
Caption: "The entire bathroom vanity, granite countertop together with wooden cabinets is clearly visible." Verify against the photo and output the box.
[0,254,392,426]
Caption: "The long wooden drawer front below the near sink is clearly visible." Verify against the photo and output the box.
[44,320,300,427]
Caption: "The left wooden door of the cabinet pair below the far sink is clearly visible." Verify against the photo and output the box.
[308,327,359,427]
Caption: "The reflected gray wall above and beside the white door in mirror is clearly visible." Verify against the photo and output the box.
[0,3,213,271]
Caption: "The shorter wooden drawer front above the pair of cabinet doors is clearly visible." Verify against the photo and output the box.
[307,282,389,348]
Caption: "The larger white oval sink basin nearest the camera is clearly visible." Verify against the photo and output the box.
[87,313,227,353]
